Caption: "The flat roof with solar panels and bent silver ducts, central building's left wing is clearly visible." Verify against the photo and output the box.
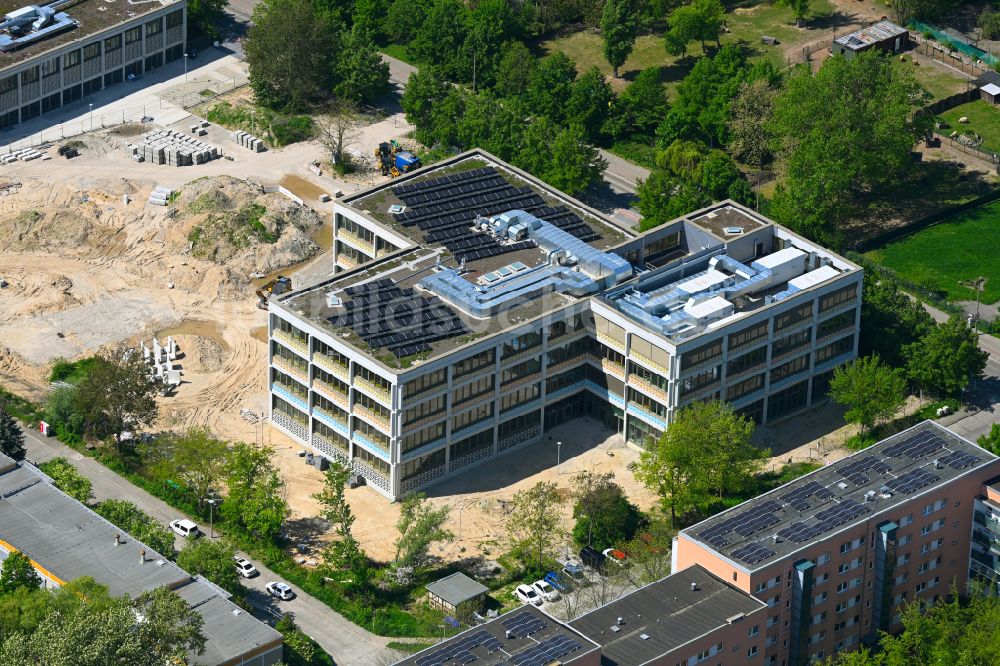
[275,153,633,367]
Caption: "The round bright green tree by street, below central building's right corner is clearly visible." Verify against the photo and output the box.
[830,356,906,435]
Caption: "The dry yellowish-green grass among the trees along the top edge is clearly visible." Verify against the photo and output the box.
[537,0,834,90]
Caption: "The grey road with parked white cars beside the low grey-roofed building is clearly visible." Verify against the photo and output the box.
[24,430,388,666]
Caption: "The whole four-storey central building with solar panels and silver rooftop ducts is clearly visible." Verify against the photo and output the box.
[268,150,862,499]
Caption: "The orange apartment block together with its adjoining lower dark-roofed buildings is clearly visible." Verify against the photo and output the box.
[390,421,1000,666]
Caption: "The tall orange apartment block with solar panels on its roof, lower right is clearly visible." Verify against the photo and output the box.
[673,421,1000,666]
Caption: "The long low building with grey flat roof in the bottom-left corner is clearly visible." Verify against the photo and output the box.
[0,454,282,666]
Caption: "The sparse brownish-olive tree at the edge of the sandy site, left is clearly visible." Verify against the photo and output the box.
[76,345,158,453]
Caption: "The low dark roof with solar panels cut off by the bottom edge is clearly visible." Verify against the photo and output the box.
[397,606,600,666]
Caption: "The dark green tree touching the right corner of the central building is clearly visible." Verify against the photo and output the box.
[858,270,934,368]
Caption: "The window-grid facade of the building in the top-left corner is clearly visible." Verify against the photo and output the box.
[0,0,187,128]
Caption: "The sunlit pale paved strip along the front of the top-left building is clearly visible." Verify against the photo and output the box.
[0,74,250,154]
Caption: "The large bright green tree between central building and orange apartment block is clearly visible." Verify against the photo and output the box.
[635,402,770,527]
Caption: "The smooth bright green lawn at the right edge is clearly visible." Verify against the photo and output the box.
[867,196,1000,303]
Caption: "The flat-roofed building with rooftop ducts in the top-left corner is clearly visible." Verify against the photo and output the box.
[0,0,187,127]
